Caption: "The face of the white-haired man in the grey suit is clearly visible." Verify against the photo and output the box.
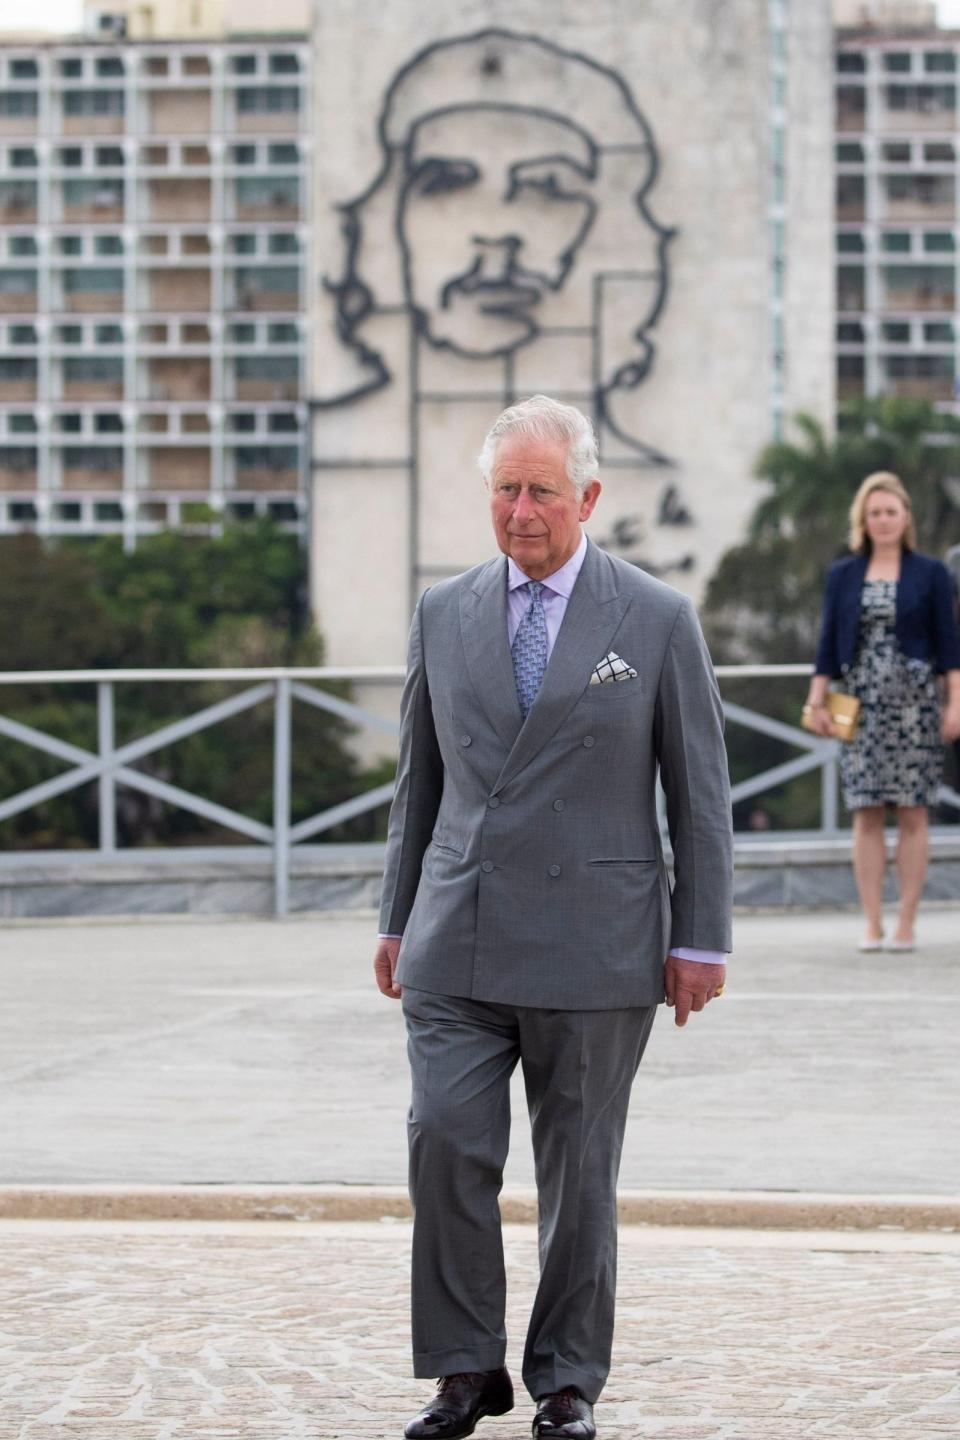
[489,435,600,580]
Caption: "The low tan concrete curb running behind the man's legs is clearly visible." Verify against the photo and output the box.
[0,1185,960,1233]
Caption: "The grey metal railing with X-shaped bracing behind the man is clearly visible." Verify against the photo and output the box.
[0,665,960,916]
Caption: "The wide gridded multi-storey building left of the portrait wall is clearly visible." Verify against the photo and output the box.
[0,28,309,546]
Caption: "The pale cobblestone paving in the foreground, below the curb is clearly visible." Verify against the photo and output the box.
[0,1223,960,1440]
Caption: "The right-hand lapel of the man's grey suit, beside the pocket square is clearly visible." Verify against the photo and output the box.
[494,541,630,791]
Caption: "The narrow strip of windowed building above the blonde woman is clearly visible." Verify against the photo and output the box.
[836,6,960,410]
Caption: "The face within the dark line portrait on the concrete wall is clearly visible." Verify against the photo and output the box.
[399,107,596,357]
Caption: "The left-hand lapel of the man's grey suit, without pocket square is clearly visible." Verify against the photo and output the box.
[461,557,521,750]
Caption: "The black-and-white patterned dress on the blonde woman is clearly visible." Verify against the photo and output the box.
[841,580,943,811]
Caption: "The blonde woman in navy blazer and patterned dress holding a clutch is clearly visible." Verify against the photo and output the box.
[807,471,960,950]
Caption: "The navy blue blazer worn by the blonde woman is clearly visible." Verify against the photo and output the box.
[815,550,960,678]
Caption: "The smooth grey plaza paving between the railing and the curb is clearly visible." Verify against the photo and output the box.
[0,907,960,1195]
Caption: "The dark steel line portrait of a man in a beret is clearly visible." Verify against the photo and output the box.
[314,29,679,472]
